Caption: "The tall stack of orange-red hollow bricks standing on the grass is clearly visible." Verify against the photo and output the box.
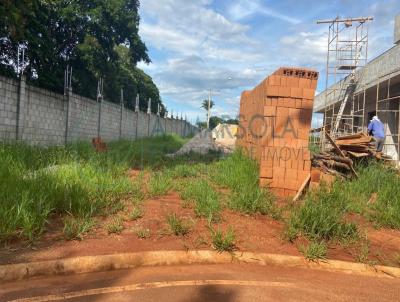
[237,67,318,197]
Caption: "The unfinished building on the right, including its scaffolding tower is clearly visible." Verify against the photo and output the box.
[314,15,400,162]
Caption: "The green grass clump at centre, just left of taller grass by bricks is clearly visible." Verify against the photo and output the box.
[181,179,221,221]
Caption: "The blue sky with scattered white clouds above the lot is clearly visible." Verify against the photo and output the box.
[139,0,400,122]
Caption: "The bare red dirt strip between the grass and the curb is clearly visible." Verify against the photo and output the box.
[0,192,400,266]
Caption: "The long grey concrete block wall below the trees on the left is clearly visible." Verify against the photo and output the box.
[0,76,198,145]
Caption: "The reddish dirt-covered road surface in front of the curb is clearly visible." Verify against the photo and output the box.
[0,264,400,302]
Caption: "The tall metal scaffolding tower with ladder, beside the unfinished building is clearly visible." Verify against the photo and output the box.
[317,17,373,149]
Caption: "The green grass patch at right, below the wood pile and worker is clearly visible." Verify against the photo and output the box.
[286,162,400,245]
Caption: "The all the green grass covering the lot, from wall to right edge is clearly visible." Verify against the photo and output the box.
[0,132,400,263]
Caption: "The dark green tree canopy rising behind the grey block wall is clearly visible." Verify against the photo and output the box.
[0,0,164,112]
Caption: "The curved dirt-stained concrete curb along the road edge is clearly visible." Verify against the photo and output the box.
[0,250,400,281]
